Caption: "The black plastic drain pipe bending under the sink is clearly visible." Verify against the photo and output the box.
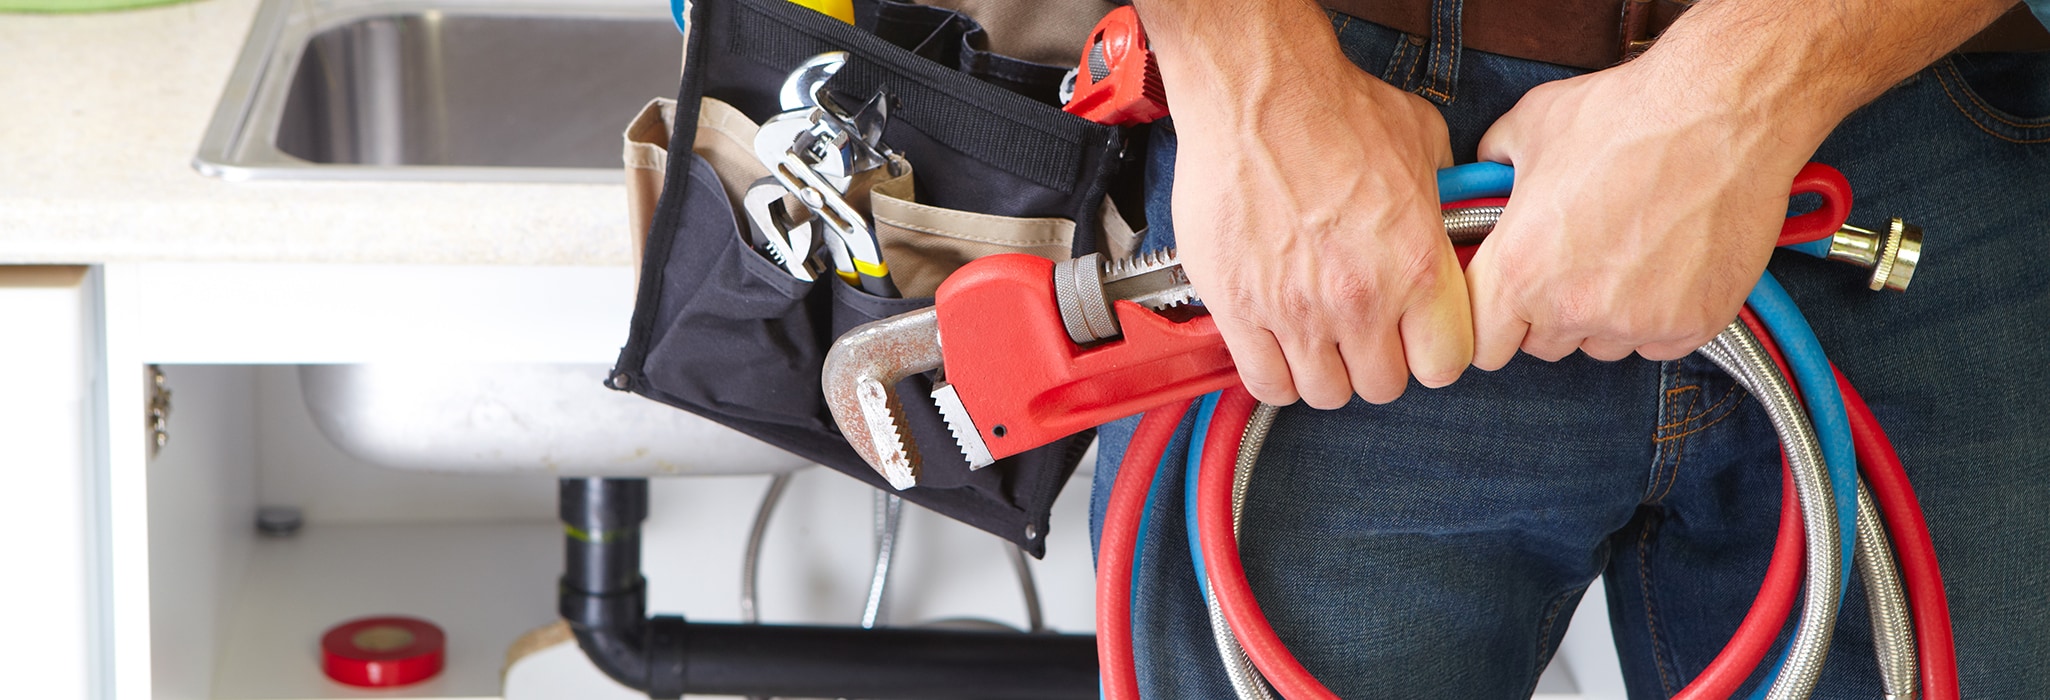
[560,478,1097,700]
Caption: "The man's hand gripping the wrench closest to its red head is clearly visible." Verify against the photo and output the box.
[1140,2,1472,409]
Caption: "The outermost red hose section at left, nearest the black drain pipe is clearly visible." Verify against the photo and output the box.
[1097,400,1197,700]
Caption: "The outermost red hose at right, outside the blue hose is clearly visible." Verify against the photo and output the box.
[1738,308,1958,700]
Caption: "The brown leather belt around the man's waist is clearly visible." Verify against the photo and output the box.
[1322,0,2050,70]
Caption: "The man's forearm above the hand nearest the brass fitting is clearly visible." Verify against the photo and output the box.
[1638,0,2015,148]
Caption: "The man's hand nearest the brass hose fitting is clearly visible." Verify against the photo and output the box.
[1466,58,1827,370]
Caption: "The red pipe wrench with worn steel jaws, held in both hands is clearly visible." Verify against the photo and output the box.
[824,164,1851,489]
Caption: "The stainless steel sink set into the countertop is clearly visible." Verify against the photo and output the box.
[193,0,683,183]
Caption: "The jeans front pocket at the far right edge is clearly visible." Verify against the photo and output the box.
[1929,53,2050,144]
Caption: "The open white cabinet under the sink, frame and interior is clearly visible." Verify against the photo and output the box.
[36,263,1620,700]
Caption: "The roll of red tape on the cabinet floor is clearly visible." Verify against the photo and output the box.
[320,616,447,688]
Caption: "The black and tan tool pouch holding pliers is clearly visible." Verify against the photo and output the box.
[609,0,1138,556]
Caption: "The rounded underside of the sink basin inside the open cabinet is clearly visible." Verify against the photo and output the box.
[299,363,810,476]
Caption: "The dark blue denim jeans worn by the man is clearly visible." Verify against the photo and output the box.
[1093,10,2050,700]
